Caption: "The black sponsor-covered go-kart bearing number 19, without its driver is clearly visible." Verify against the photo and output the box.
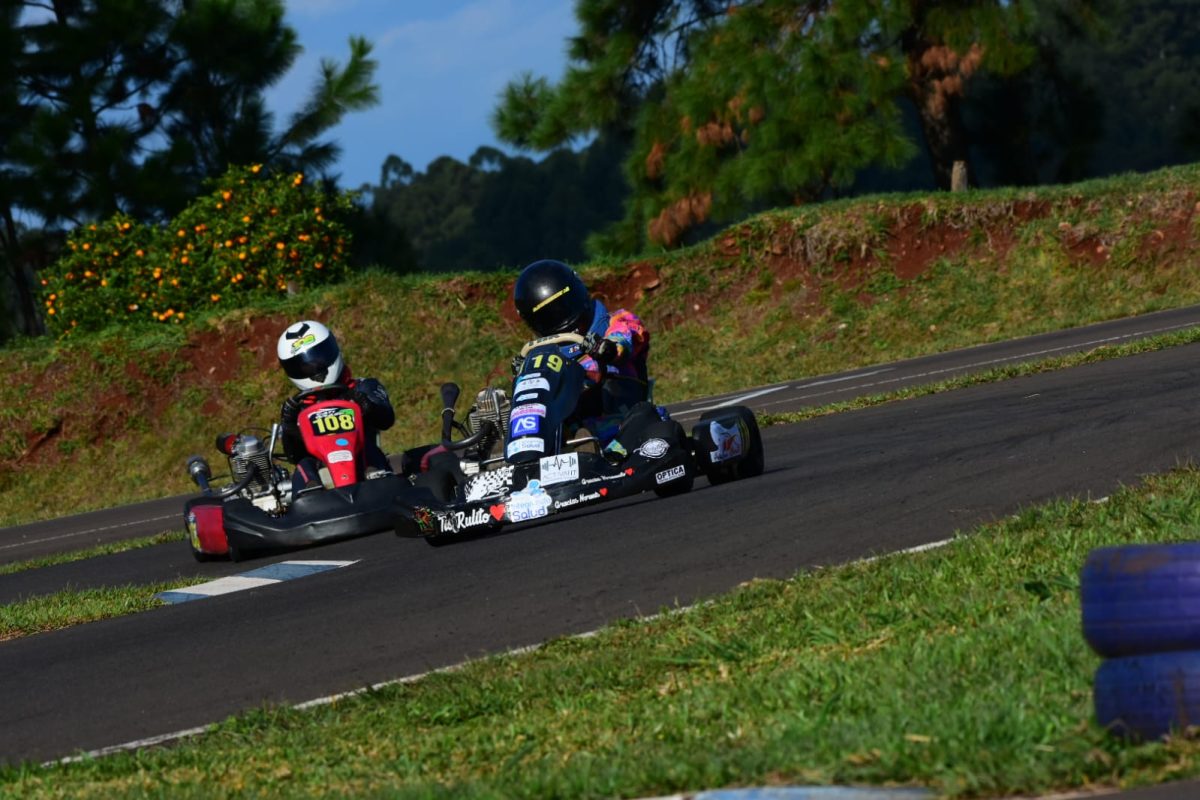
[396,333,763,545]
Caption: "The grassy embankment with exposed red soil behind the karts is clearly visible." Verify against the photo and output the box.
[0,166,1200,525]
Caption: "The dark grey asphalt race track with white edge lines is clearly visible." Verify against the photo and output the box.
[7,309,1200,796]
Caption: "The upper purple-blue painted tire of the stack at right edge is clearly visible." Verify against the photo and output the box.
[1079,542,1200,657]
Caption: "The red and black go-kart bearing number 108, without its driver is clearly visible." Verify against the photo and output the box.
[184,386,414,561]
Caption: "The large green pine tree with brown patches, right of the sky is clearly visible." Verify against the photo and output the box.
[493,0,1060,251]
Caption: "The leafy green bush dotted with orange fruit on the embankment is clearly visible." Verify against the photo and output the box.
[41,166,353,336]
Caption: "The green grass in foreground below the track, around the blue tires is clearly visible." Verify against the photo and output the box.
[7,469,1200,798]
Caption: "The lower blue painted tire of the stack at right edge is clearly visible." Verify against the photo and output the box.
[1093,650,1200,740]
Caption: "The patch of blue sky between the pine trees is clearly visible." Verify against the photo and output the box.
[266,0,575,188]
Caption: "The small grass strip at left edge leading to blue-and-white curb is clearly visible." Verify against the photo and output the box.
[0,578,203,642]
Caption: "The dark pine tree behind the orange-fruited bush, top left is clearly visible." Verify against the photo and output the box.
[0,0,378,332]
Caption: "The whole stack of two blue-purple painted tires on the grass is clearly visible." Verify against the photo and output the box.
[1080,542,1200,739]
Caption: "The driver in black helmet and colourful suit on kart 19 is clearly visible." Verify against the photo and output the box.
[512,259,650,445]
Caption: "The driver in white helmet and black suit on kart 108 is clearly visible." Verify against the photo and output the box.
[275,320,396,492]
